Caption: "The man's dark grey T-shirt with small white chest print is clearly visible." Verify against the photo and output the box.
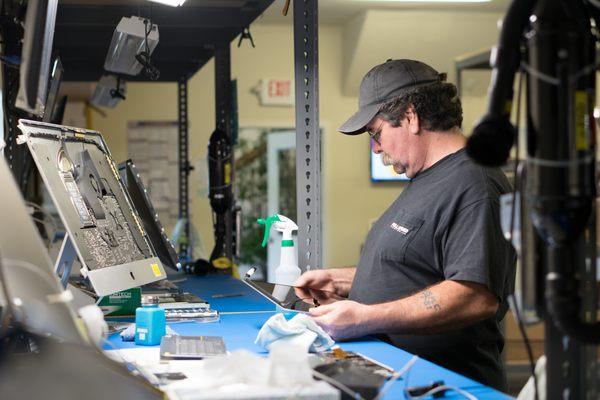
[349,149,516,390]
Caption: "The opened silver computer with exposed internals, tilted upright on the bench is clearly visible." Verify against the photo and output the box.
[18,119,166,296]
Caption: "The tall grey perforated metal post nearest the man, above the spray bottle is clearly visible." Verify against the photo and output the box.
[294,0,321,271]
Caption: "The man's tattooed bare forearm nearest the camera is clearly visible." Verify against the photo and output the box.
[367,280,498,334]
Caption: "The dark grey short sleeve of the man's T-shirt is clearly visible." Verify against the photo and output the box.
[443,198,516,300]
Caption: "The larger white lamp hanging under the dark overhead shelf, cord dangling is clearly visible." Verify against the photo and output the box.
[104,16,158,75]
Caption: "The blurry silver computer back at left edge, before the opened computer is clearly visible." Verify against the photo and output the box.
[0,157,84,343]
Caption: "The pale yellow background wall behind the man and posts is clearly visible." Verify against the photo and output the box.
[92,11,499,266]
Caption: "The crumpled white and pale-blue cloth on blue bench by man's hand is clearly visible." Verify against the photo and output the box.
[254,313,335,353]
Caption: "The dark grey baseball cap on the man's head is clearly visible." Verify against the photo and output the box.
[339,60,446,135]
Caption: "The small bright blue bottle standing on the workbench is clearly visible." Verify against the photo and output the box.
[135,296,167,346]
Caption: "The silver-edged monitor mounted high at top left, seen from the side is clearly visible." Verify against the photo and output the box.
[15,0,58,116]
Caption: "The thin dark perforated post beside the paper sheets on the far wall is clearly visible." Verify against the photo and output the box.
[177,78,191,261]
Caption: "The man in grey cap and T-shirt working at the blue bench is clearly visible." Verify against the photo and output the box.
[296,60,515,390]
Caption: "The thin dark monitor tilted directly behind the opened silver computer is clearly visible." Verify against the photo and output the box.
[119,160,181,271]
